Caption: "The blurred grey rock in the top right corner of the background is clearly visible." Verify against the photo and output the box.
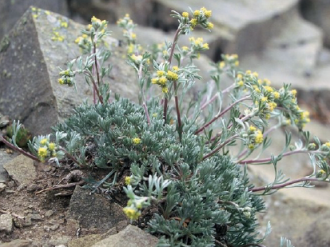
[300,0,330,47]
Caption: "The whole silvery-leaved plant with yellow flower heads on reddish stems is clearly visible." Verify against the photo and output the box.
[1,8,330,247]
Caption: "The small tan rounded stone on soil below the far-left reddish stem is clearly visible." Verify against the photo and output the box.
[3,154,37,185]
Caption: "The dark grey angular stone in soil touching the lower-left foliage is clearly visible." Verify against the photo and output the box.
[67,186,126,230]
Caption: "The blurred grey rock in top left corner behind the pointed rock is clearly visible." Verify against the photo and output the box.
[0,0,68,40]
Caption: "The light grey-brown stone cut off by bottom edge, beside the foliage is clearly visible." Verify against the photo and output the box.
[92,225,158,247]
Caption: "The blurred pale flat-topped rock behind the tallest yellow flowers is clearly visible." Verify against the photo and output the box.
[154,0,298,55]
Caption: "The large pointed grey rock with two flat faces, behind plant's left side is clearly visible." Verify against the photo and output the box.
[0,9,138,134]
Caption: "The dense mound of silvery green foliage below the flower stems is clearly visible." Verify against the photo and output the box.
[56,99,264,246]
